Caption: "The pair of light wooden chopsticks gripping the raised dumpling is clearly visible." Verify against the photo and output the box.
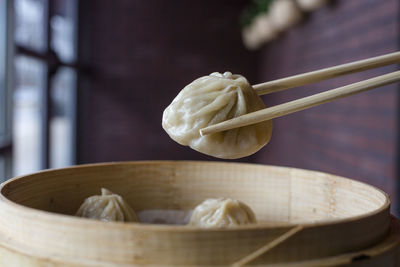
[200,52,400,136]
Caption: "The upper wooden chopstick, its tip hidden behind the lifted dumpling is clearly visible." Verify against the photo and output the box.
[253,52,400,95]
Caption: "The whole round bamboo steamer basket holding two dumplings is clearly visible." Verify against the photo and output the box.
[0,161,400,266]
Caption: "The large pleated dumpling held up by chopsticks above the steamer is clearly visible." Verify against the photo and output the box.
[162,72,272,159]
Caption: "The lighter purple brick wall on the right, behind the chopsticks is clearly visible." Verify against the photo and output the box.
[257,0,400,214]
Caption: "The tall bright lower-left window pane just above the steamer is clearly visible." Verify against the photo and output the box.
[13,55,47,175]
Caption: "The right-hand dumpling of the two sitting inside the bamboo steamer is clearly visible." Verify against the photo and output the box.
[189,198,257,228]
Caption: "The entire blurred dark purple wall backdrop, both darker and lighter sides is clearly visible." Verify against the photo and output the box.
[78,0,400,214]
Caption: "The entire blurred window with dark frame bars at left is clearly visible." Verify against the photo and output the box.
[5,0,78,180]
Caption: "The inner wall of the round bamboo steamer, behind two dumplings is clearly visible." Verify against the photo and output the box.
[1,162,389,224]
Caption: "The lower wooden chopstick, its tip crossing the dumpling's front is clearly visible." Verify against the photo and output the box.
[200,71,400,136]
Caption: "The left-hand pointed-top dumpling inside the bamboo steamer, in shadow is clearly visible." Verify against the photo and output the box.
[76,188,139,222]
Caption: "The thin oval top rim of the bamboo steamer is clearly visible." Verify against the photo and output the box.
[0,160,390,232]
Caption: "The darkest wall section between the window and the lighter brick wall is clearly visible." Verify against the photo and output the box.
[78,0,257,163]
